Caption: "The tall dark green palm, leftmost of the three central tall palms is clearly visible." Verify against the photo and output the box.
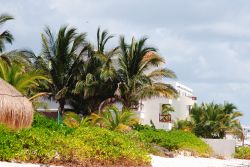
[38,26,87,114]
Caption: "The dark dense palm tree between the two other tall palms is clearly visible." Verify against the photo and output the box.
[71,28,118,114]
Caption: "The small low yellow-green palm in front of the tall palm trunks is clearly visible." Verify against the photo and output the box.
[90,105,138,131]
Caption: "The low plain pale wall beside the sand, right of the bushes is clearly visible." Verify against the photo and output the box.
[203,139,236,158]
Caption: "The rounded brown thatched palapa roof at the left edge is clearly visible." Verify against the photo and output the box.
[0,78,33,129]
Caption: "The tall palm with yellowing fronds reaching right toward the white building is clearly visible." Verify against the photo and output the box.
[116,37,177,108]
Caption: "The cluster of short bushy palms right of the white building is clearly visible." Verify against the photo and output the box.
[175,103,242,138]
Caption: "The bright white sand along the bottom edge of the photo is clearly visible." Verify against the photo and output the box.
[0,155,250,167]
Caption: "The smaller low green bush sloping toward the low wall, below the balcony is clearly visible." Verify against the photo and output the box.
[137,126,211,156]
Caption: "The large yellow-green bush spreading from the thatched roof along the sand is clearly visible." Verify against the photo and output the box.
[0,115,149,164]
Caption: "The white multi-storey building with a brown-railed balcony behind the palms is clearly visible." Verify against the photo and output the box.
[139,82,197,130]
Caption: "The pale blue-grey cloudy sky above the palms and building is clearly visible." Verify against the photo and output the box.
[0,0,250,124]
